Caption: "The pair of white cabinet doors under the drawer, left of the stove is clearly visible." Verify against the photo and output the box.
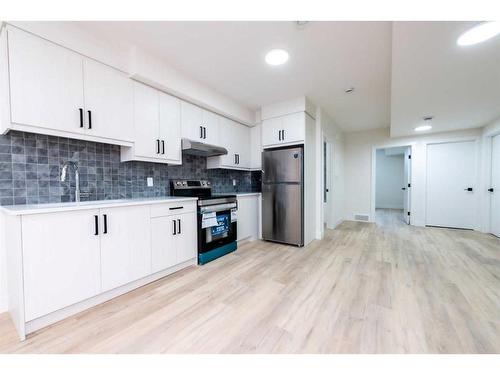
[151,212,197,272]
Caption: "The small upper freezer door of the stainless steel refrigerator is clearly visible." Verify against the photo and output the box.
[262,147,303,183]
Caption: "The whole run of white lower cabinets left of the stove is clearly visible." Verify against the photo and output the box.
[5,198,197,339]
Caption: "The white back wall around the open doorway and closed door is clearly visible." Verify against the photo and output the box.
[344,128,484,229]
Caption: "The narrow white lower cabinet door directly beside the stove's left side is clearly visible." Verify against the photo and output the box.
[175,213,198,263]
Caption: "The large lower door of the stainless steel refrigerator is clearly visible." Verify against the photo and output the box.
[262,183,304,246]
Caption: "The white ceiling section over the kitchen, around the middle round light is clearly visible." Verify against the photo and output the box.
[79,21,391,131]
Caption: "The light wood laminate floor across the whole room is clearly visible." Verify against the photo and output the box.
[0,213,500,353]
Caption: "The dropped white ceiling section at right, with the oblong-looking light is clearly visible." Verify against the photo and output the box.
[391,22,500,136]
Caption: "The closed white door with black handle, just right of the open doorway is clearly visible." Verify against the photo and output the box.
[426,141,476,229]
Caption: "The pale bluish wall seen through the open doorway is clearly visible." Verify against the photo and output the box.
[375,149,404,209]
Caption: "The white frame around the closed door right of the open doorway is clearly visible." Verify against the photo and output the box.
[423,137,482,231]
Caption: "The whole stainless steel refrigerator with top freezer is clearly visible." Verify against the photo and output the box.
[262,146,304,246]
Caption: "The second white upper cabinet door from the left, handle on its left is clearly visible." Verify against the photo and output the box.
[83,59,134,142]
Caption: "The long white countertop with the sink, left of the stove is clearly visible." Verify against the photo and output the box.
[0,197,198,215]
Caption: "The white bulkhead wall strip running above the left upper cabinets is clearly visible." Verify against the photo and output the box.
[9,21,255,126]
